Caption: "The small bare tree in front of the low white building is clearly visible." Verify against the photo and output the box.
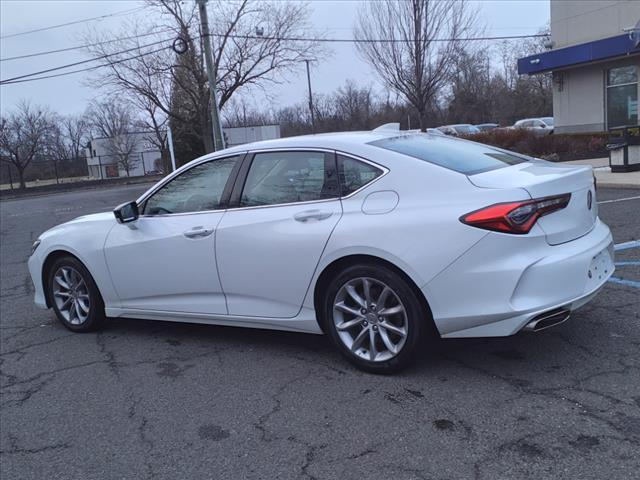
[87,98,141,176]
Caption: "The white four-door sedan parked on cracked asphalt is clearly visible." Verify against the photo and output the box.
[29,129,614,372]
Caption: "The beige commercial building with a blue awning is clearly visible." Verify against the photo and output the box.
[518,0,640,133]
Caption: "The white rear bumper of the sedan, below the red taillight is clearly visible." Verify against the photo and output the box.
[422,219,614,337]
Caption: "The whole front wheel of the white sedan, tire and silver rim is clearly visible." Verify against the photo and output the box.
[47,256,105,332]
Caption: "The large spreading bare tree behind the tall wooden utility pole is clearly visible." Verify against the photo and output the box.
[88,0,319,155]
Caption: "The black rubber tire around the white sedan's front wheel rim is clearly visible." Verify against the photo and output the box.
[47,256,106,333]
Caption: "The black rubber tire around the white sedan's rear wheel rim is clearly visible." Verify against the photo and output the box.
[321,264,432,374]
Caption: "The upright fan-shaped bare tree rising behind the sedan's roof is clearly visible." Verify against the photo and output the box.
[354,0,477,131]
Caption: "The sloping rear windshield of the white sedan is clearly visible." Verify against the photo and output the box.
[370,135,528,175]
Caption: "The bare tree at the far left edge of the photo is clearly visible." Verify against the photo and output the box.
[0,101,52,188]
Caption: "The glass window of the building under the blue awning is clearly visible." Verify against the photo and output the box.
[607,65,638,128]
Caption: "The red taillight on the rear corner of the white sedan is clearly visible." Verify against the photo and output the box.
[460,193,571,234]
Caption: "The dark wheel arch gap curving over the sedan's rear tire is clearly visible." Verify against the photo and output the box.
[313,254,440,336]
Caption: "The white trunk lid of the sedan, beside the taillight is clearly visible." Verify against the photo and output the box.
[468,160,598,245]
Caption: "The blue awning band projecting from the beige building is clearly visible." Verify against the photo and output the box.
[518,33,640,75]
